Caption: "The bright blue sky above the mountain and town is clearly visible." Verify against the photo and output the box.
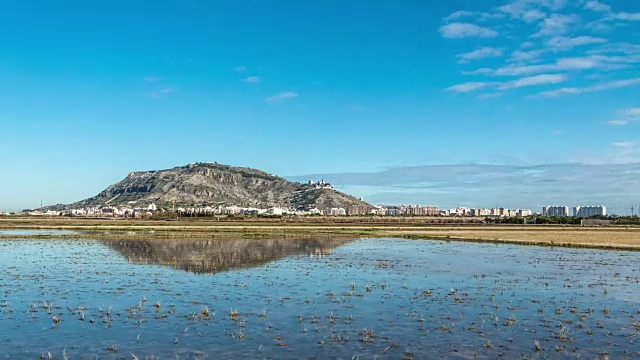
[0,0,640,212]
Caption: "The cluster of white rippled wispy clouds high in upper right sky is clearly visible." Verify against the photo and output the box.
[440,0,640,100]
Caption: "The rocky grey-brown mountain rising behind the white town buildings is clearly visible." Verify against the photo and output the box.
[66,163,371,211]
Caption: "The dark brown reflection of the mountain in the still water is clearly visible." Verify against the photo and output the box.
[103,239,352,274]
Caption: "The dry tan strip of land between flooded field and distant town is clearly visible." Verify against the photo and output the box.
[0,219,640,250]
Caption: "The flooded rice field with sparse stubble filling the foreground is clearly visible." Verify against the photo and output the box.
[0,235,640,359]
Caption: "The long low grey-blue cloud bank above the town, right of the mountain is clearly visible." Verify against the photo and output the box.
[292,162,640,212]
